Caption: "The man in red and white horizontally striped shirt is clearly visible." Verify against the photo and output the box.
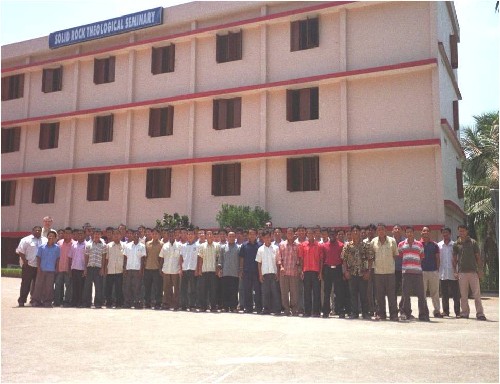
[398,226,429,321]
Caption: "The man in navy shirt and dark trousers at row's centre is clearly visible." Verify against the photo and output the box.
[240,228,262,313]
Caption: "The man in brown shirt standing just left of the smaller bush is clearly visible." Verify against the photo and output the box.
[144,228,163,309]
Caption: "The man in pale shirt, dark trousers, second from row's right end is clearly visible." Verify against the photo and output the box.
[438,227,460,317]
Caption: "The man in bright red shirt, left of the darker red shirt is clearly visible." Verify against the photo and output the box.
[299,228,324,317]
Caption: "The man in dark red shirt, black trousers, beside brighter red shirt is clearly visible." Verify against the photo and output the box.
[321,229,345,319]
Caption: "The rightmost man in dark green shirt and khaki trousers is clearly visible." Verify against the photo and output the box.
[453,225,486,321]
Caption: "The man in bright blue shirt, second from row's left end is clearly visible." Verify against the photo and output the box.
[33,229,60,308]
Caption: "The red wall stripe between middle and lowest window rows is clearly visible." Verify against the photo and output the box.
[2,139,441,180]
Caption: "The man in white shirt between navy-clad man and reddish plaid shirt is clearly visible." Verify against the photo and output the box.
[255,230,281,316]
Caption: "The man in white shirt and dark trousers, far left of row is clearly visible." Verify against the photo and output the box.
[16,225,47,307]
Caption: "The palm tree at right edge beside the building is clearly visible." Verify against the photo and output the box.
[461,111,499,289]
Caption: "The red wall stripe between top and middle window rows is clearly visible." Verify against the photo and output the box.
[2,58,437,127]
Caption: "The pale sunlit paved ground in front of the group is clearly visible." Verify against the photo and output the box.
[1,278,499,383]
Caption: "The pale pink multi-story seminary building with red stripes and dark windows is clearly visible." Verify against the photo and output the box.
[2,1,464,260]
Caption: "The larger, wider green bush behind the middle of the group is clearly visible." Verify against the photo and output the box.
[215,204,271,229]
